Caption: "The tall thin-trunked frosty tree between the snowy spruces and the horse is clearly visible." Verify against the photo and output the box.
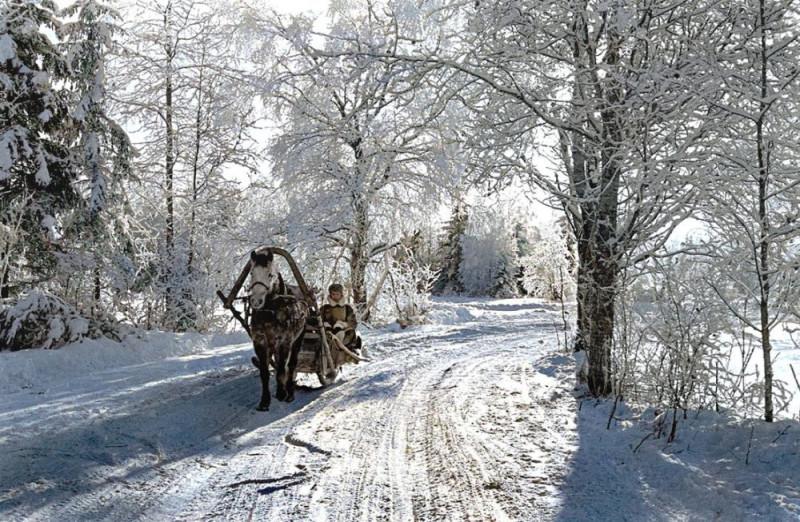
[112,0,258,329]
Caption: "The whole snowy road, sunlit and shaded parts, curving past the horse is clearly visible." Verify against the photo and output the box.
[0,302,574,521]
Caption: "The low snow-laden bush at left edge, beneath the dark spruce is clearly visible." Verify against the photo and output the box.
[0,291,121,351]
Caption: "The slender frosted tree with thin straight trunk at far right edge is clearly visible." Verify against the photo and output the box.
[704,0,800,422]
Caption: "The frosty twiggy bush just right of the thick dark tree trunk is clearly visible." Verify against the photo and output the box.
[614,255,792,426]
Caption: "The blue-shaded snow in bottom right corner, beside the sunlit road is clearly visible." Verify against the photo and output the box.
[556,399,800,522]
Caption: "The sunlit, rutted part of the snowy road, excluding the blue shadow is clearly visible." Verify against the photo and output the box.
[164,304,574,522]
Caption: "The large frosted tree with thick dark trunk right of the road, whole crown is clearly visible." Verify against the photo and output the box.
[324,0,722,395]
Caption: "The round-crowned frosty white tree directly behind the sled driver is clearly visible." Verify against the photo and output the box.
[253,2,458,312]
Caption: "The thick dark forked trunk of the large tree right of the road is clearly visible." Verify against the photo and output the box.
[571,2,623,396]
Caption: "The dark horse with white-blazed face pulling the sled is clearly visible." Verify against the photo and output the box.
[248,247,309,411]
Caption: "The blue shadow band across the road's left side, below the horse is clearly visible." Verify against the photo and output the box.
[0,355,330,519]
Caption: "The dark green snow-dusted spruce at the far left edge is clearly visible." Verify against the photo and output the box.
[0,0,79,297]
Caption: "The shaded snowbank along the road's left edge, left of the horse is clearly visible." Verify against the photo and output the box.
[0,332,248,395]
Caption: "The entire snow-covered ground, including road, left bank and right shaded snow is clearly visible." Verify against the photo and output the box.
[0,300,800,521]
